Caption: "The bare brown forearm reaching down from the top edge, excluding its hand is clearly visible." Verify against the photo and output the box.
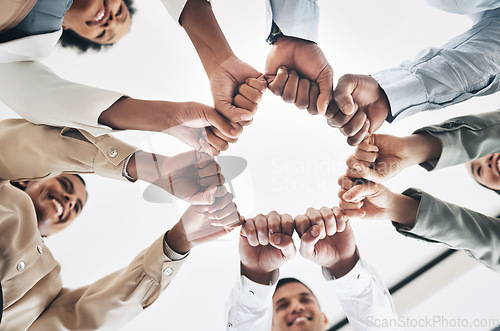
[179,0,234,76]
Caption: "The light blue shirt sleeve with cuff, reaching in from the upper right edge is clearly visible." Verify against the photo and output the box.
[372,10,500,121]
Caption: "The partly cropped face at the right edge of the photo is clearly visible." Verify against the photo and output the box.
[467,153,500,190]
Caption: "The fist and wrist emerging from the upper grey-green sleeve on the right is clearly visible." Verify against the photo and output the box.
[346,133,442,183]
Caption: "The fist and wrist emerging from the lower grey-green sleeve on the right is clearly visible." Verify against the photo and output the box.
[338,176,419,228]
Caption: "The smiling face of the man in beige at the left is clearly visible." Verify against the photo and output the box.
[24,174,87,236]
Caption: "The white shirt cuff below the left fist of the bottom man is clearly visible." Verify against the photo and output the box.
[239,270,279,309]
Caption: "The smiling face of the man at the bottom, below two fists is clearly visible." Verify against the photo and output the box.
[273,282,328,331]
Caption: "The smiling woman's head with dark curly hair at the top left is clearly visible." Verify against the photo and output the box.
[59,0,135,52]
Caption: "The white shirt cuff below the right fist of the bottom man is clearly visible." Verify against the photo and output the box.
[321,258,371,296]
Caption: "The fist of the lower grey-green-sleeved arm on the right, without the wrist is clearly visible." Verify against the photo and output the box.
[338,176,395,219]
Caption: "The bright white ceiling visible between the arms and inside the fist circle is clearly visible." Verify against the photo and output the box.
[0,0,500,330]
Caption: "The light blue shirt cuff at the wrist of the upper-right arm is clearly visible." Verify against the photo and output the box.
[371,67,427,122]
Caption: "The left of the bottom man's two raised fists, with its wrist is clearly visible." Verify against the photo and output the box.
[240,211,295,284]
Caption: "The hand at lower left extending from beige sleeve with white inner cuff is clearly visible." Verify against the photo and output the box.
[167,186,243,254]
